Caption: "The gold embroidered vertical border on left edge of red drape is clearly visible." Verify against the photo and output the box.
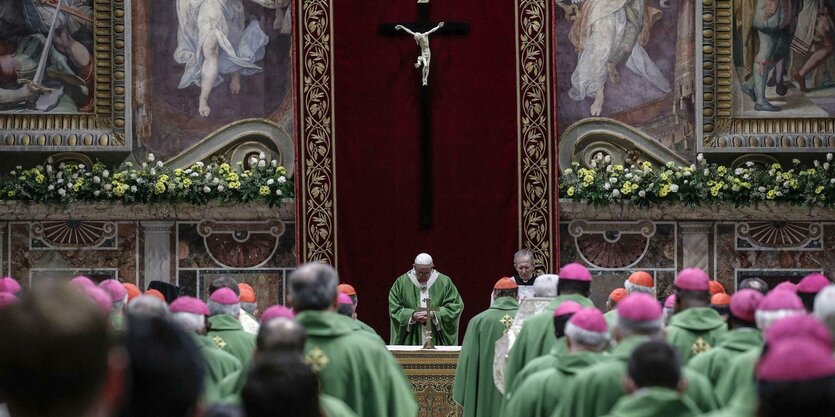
[296,0,336,265]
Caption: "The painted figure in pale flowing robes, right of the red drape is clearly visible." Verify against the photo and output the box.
[568,0,672,116]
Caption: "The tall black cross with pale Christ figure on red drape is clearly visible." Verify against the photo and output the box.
[380,0,470,229]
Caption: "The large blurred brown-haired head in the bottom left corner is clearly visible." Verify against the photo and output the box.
[0,284,110,417]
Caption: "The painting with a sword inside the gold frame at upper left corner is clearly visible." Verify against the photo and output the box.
[0,0,94,112]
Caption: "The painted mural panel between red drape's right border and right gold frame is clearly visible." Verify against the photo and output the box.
[554,0,695,155]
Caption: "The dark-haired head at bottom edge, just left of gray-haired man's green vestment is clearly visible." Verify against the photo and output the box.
[241,353,321,417]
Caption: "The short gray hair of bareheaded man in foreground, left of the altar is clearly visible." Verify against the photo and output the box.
[290,263,339,311]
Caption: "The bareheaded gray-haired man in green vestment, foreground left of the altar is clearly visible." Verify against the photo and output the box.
[290,263,418,417]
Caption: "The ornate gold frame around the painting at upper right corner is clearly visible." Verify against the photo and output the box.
[696,0,835,153]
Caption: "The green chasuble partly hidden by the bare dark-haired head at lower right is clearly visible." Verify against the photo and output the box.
[552,336,717,417]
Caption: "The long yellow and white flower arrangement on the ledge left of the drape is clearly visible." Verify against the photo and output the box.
[0,153,293,207]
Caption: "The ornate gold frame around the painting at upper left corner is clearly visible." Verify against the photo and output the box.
[0,0,131,152]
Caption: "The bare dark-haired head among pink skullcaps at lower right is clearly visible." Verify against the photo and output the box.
[627,340,681,390]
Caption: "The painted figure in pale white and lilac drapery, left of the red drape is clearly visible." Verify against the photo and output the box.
[174,0,276,117]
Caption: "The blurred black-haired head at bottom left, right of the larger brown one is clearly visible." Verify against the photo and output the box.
[121,316,205,417]
